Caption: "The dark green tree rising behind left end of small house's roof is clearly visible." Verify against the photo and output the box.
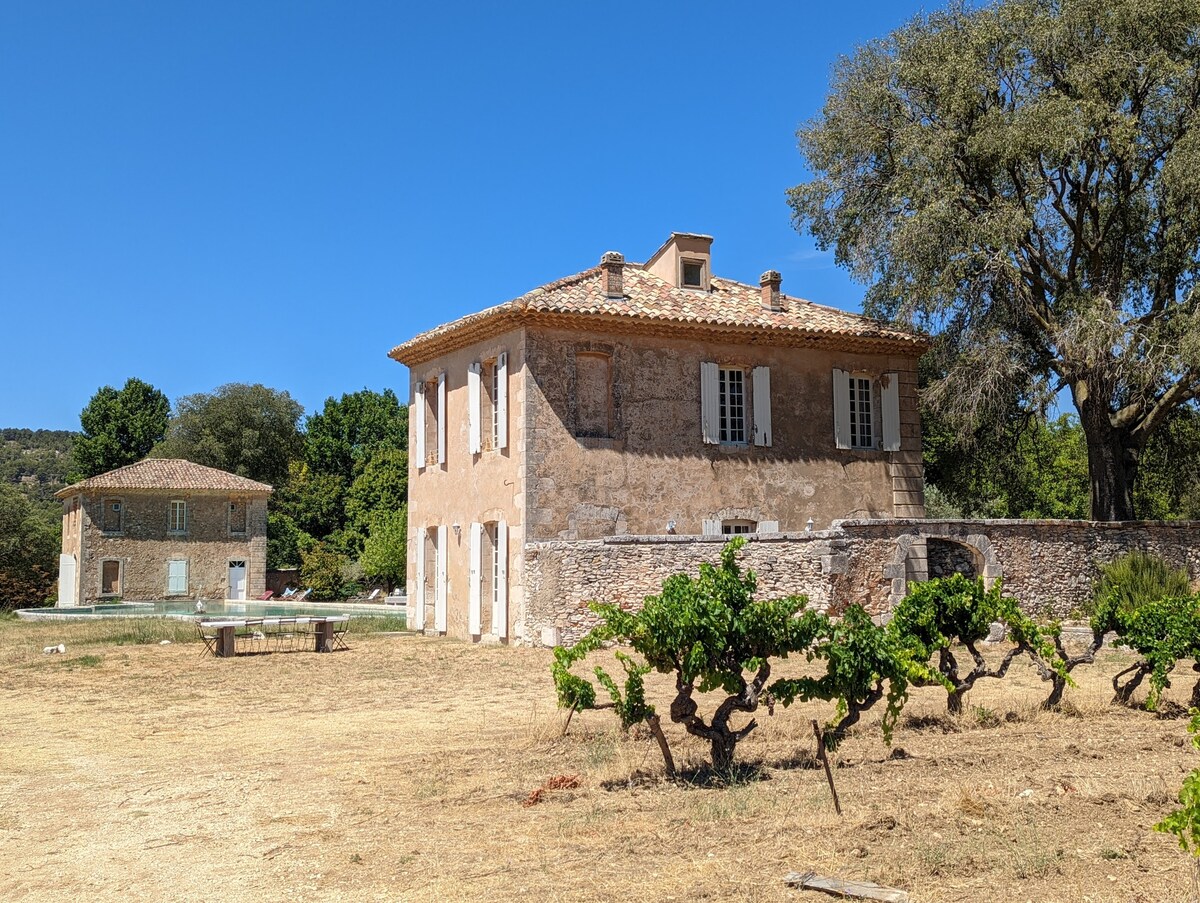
[72,378,170,479]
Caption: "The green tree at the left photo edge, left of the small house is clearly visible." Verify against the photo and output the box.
[0,483,62,609]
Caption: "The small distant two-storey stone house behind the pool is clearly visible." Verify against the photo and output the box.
[55,459,271,606]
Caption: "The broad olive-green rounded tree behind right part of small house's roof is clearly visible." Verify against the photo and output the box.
[154,383,304,486]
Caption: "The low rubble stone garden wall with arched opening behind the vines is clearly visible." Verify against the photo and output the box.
[522,520,1200,642]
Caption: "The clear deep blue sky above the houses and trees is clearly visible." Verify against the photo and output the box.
[0,0,919,429]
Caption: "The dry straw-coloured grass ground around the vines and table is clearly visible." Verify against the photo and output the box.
[0,621,1200,903]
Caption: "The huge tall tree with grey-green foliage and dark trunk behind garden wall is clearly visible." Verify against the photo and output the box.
[790,0,1200,520]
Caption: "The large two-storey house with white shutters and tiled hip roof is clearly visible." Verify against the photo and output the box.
[390,233,928,641]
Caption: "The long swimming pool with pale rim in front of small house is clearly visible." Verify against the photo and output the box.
[16,599,404,621]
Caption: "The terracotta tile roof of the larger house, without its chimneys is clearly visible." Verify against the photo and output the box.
[389,263,928,363]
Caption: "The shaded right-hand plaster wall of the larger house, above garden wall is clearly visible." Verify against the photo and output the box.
[524,328,924,542]
